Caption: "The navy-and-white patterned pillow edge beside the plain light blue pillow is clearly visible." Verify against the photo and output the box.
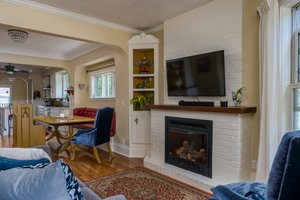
[56,160,84,200]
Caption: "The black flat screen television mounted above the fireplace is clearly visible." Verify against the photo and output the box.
[166,50,226,97]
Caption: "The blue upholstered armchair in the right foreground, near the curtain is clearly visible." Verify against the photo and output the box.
[211,131,300,200]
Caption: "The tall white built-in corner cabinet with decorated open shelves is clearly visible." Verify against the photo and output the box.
[128,33,159,157]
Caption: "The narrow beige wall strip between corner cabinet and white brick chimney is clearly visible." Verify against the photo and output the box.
[153,30,164,104]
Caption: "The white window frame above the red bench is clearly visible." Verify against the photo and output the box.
[88,65,116,100]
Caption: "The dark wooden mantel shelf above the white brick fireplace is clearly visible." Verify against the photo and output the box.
[151,105,256,114]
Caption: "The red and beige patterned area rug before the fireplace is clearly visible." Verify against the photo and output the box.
[87,167,210,200]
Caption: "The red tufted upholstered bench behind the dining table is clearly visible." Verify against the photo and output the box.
[73,107,116,137]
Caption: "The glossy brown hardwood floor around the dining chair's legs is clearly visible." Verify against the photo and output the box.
[0,136,143,182]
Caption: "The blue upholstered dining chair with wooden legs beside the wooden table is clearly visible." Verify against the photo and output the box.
[71,107,114,164]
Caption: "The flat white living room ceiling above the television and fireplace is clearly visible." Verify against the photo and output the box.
[25,0,211,30]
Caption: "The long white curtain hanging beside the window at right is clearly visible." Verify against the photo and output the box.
[256,0,281,182]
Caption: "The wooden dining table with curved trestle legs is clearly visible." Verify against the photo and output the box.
[33,115,95,153]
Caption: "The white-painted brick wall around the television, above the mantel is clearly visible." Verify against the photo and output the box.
[164,0,245,105]
